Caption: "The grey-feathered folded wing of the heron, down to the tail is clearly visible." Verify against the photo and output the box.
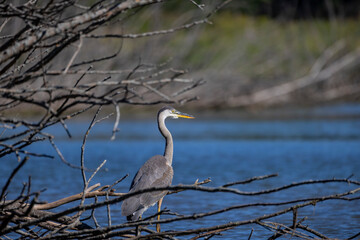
[121,155,173,216]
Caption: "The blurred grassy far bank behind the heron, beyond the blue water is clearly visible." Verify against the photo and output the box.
[4,5,360,119]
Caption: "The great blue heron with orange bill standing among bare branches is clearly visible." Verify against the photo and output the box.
[121,107,194,232]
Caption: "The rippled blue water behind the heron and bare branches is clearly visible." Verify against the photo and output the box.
[0,108,360,239]
